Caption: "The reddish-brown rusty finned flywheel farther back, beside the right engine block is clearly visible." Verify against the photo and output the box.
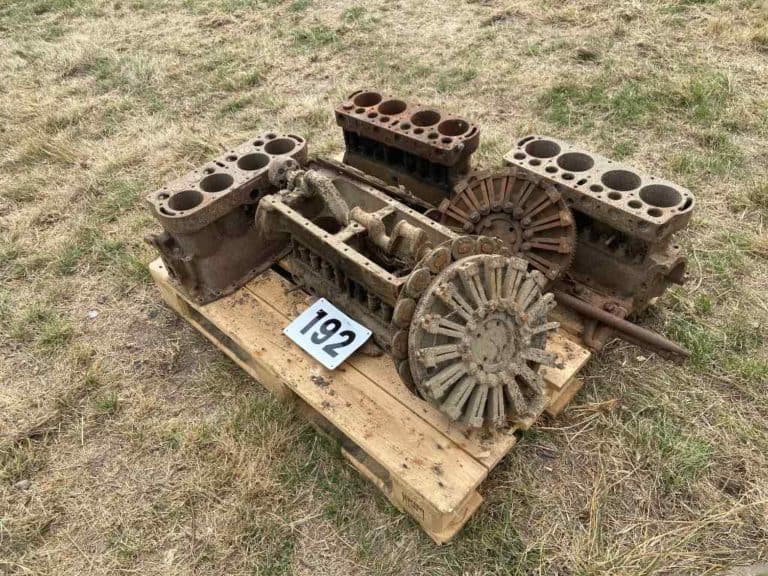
[437,167,576,281]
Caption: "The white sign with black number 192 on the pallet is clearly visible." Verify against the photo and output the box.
[283,298,371,370]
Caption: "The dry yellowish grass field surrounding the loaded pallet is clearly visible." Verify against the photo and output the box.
[0,0,768,576]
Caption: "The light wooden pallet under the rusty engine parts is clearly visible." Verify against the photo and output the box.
[150,259,590,543]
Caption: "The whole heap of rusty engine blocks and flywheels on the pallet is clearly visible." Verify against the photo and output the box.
[147,90,695,428]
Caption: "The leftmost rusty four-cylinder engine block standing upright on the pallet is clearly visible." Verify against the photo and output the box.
[146,132,307,303]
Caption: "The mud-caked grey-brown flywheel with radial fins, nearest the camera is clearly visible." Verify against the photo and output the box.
[408,254,558,428]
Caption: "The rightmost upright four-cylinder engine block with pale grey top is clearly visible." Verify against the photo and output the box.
[504,136,695,322]
